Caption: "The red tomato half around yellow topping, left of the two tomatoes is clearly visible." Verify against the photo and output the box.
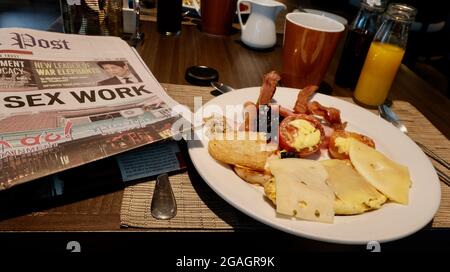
[279,114,325,157]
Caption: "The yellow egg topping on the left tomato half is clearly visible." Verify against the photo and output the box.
[289,119,320,150]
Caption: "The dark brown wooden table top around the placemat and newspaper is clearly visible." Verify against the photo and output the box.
[0,22,450,251]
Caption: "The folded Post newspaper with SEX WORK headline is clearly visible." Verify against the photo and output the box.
[0,28,189,190]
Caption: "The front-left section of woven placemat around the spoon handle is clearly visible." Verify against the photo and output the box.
[120,170,266,230]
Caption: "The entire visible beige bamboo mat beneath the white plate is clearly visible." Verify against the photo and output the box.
[120,84,450,231]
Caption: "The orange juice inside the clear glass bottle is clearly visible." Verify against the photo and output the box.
[354,42,405,106]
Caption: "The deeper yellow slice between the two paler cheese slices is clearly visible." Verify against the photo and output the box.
[320,160,387,215]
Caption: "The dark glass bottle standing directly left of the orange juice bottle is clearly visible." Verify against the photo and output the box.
[335,0,386,89]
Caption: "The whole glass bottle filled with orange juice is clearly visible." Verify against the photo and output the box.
[354,3,416,107]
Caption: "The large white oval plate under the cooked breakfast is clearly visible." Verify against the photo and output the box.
[188,87,441,244]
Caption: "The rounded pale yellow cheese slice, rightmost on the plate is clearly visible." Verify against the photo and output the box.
[349,140,411,204]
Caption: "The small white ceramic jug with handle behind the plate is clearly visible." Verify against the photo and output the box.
[237,0,286,49]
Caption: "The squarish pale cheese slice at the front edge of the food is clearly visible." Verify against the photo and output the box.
[269,158,335,223]
